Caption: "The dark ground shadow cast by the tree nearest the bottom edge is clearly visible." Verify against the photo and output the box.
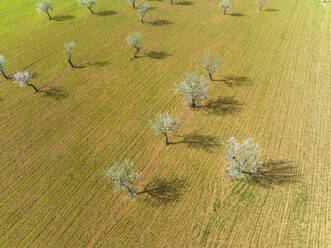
[137,179,184,206]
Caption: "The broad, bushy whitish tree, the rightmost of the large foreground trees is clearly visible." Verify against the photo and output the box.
[225,137,263,181]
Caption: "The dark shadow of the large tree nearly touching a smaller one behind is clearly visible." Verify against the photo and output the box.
[197,96,244,115]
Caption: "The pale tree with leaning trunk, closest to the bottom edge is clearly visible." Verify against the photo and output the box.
[104,159,140,201]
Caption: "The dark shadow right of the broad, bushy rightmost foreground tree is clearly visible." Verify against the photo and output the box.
[248,160,301,187]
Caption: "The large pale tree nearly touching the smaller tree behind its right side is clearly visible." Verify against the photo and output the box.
[175,73,209,108]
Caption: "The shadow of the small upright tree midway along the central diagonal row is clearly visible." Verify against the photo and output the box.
[170,132,220,152]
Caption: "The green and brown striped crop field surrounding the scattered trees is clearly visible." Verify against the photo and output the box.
[0,0,331,247]
